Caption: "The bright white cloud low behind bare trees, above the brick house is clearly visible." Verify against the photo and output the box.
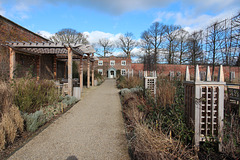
[83,31,121,44]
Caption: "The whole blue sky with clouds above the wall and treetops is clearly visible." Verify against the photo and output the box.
[0,0,240,47]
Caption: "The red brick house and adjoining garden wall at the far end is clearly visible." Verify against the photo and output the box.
[95,56,240,82]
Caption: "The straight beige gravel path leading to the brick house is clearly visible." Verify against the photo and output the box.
[9,79,129,160]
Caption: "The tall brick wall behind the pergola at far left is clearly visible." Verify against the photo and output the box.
[0,16,48,77]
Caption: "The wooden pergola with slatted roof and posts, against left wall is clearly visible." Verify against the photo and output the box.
[6,42,96,96]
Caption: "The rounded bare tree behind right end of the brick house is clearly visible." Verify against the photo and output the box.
[118,32,138,57]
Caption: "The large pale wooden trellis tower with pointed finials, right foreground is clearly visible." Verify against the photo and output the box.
[184,65,226,151]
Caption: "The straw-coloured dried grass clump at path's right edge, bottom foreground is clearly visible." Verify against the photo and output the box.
[131,123,197,160]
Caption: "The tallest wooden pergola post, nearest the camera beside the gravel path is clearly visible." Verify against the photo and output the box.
[67,47,72,96]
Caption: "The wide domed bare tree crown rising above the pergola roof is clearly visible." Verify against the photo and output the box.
[50,28,89,44]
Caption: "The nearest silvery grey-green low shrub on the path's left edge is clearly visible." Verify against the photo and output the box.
[23,110,46,132]
